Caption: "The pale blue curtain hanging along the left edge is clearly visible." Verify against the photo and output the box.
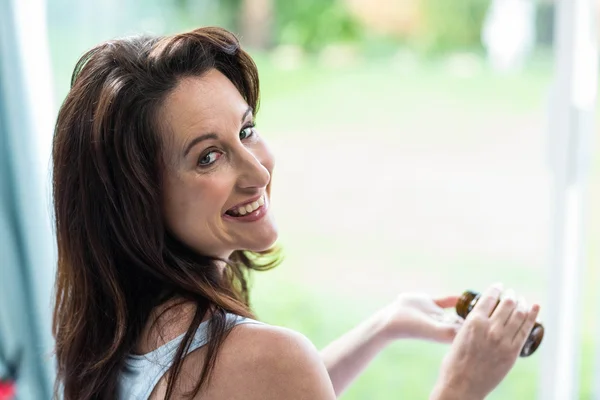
[0,0,56,400]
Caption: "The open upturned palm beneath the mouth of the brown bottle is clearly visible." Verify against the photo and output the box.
[383,293,463,343]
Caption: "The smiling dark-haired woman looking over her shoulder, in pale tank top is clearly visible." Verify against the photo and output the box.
[53,28,539,400]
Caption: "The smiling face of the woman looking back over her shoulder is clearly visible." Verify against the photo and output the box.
[159,69,277,258]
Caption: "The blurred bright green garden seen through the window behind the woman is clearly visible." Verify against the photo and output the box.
[48,0,600,400]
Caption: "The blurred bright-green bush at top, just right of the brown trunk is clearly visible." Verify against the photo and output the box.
[274,0,361,51]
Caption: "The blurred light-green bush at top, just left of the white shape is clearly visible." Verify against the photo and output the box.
[413,0,490,53]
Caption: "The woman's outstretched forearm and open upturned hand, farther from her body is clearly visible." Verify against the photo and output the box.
[321,293,462,396]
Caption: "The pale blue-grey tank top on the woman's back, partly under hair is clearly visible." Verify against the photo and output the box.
[117,314,262,400]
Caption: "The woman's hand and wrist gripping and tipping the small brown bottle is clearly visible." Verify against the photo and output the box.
[431,285,540,400]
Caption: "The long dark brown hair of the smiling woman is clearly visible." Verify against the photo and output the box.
[52,28,280,400]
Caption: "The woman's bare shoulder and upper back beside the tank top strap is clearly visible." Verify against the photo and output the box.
[173,324,335,400]
